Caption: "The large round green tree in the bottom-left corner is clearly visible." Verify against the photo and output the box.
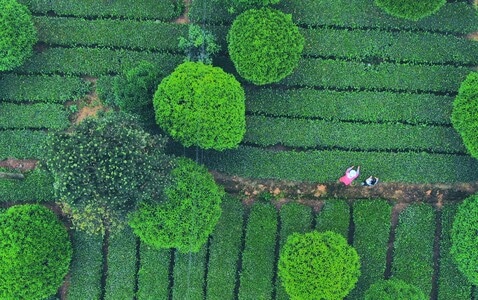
[0,205,72,300]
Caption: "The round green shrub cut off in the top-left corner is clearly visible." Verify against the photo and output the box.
[0,0,37,71]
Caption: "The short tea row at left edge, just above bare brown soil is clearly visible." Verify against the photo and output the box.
[0,129,47,160]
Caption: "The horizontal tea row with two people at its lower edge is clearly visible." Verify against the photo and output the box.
[205,146,478,183]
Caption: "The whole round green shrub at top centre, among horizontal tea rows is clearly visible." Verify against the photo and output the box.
[227,8,304,85]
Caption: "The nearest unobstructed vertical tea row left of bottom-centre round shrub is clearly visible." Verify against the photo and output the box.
[238,203,277,300]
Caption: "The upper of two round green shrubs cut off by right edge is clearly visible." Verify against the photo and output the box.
[451,72,478,158]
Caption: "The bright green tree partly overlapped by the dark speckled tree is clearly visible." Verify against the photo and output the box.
[129,159,224,253]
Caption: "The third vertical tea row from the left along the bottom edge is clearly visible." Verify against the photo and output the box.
[137,243,171,300]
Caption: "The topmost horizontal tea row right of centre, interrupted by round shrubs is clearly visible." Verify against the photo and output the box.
[189,0,478,35]
